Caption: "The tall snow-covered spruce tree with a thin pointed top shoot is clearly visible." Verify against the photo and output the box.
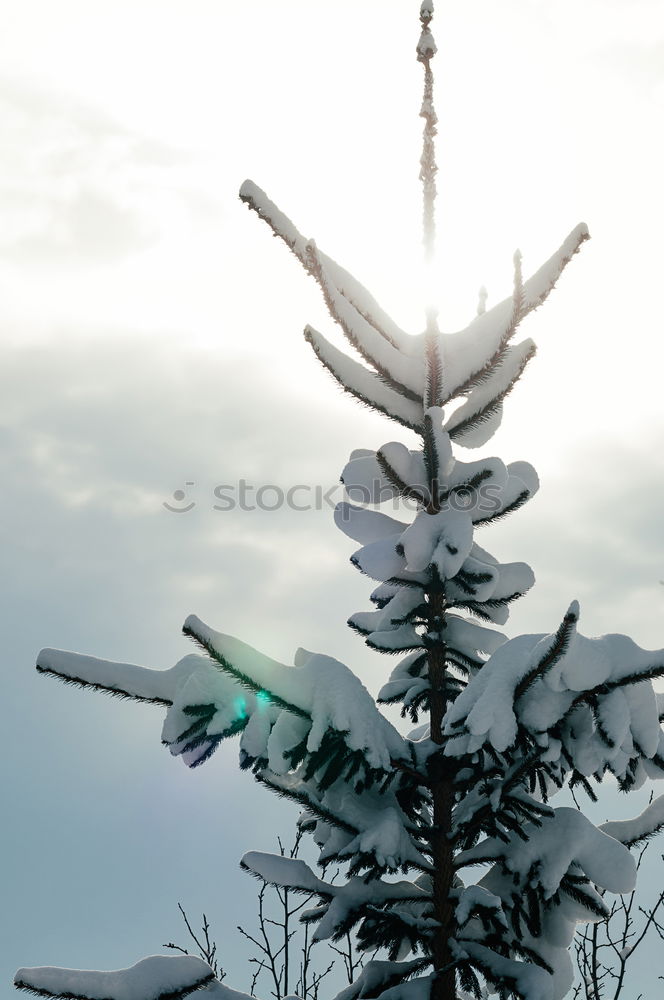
[11,2,664,1000]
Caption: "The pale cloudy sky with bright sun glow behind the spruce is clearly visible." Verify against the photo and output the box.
[0,0,664,998]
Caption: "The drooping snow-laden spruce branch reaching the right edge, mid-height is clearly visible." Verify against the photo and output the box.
[445,604,664,784]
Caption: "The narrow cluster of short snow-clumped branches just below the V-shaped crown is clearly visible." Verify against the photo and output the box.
[335,424,539,680]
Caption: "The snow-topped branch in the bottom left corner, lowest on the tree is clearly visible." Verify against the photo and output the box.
[14,955,215,1000]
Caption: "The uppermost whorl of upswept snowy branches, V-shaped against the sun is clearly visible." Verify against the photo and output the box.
[240,181,588,448]
